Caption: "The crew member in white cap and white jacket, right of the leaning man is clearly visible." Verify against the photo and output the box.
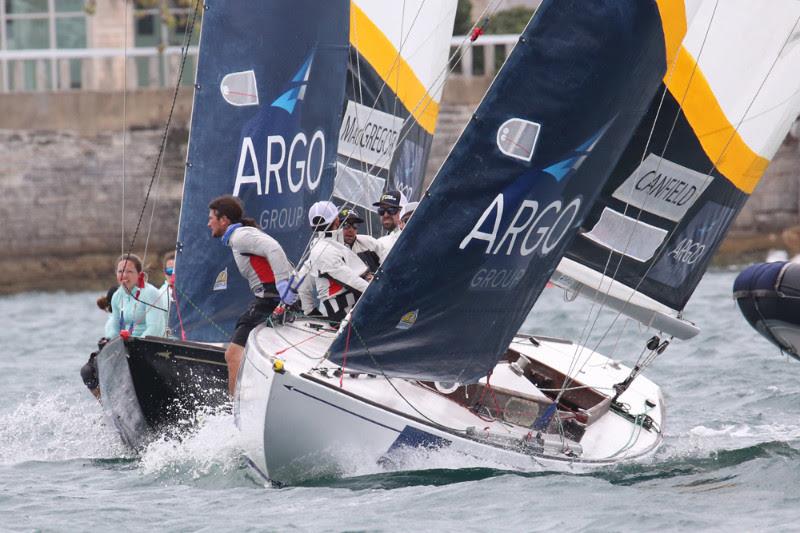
[298,201,371,321]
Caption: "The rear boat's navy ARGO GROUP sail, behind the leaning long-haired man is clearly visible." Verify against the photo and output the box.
[170,0,349,342]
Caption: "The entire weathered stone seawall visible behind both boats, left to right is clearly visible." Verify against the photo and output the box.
[0,88,800,293]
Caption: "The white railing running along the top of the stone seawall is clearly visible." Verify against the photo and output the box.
[0,35,518,93]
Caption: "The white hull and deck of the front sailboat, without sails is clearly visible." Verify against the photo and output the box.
[236,320,663,483]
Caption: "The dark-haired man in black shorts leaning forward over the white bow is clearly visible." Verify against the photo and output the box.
[208,195,297,395]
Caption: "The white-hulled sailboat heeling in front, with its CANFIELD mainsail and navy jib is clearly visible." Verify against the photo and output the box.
[234,0,800,484]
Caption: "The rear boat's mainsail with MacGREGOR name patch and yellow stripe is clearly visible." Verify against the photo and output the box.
[336,0,457,211]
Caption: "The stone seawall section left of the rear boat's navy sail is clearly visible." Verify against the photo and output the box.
[0,128,187,292]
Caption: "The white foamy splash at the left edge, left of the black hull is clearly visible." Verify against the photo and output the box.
[0,387,133,465]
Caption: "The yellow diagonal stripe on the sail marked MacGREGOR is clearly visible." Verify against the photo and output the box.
[350,2,439,135]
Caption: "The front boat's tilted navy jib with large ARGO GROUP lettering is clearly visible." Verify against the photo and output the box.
[324,0,679,382]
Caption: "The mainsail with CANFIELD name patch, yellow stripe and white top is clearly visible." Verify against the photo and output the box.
[554,0,800,338]
